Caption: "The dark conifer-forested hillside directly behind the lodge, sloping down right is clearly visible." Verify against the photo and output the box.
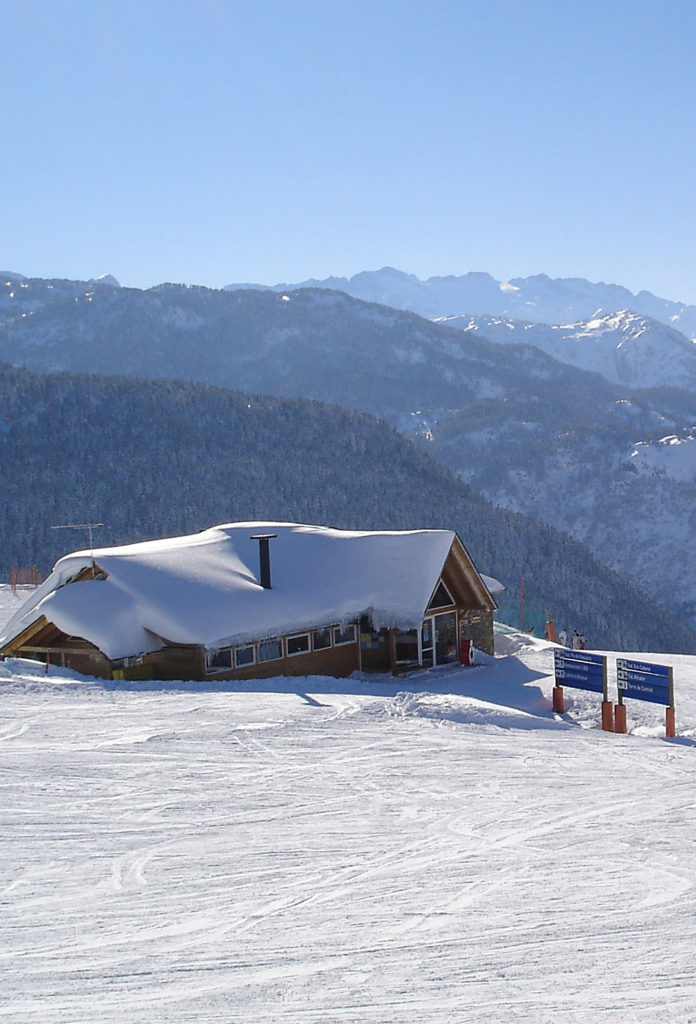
[0,367,696,651]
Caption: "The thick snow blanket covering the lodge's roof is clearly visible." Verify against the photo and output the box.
[0,522,495,659]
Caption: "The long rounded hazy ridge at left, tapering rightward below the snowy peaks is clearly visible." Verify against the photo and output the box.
[0,280,597,422]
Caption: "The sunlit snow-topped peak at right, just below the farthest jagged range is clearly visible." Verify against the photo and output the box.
[437,309,696,391]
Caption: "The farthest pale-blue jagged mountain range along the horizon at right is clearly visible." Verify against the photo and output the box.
[227,267,696,338]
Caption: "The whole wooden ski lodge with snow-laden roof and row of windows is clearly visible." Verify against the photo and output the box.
[0,522,499,680]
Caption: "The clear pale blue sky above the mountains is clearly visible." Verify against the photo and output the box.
[5,0,696,302]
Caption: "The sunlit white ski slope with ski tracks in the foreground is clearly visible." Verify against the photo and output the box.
[0,606,696,1024]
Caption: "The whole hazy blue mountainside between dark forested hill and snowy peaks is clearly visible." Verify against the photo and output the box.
[0,280,696,634]
